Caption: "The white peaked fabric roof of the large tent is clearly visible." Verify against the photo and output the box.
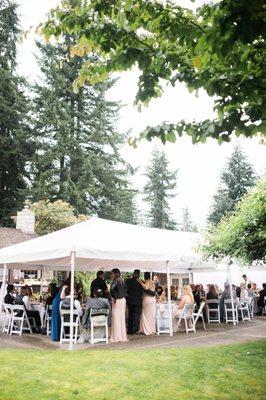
[0,217,214,272]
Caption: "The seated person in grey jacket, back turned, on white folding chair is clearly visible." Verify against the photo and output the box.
[83,288,111,328]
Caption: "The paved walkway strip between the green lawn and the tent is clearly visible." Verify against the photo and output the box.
[0,317,266,350]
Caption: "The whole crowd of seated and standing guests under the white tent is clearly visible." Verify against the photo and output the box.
[4,268,266,342]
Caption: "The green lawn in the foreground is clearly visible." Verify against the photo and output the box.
[0,341,266,400]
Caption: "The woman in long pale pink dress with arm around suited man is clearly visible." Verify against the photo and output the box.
[139,272,156,335]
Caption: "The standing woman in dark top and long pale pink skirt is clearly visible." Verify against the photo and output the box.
[110,268,128,342]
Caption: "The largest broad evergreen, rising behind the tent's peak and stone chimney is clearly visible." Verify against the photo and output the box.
[31,37,134,222]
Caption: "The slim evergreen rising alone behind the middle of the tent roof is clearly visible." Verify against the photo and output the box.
[144,149,177,229]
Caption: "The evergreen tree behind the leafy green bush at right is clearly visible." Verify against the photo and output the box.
[208,146,255,225]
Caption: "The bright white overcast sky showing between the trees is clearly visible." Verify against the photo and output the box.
[17,0,265,226]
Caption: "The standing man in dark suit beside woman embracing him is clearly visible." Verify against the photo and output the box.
[126,269,143,335]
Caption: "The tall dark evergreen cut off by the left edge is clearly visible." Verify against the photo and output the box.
[0,0,33,226]
